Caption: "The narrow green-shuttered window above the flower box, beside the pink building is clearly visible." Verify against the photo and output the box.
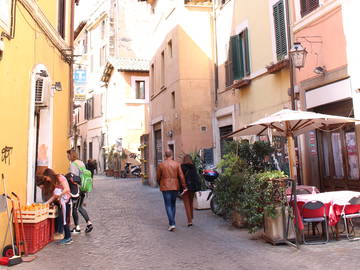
[273,0,287,61]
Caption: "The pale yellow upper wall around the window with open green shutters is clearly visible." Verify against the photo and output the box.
[217,0,290,128]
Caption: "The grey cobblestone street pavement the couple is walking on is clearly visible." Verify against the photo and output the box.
[12,177,360,270]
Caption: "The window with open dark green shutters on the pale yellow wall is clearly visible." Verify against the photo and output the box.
[225,29,250,86]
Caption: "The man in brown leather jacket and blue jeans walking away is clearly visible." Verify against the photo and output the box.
[157,150,187,231]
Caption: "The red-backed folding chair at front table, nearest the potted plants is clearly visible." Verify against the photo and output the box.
[301,201,329,245]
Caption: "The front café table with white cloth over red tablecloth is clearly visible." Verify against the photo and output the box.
[296,190,360,238]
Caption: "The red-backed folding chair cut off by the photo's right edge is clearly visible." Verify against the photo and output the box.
[341,196,360,240]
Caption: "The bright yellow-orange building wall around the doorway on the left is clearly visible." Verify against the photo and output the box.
[0,1,70,247]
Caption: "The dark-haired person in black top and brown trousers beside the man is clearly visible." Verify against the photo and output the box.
[181,155,201,227]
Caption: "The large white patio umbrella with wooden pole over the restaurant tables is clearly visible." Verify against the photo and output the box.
[225,109,360,178]
